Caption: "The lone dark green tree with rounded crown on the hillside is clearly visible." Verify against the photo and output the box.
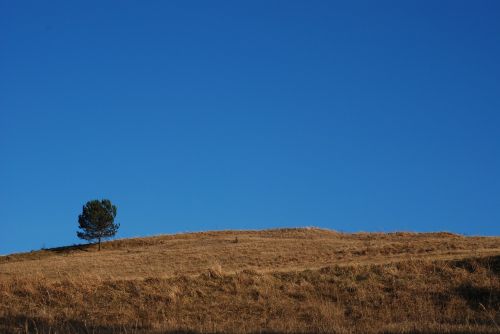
[76,199,120,250]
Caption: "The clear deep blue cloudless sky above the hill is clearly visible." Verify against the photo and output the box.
[0,0,500,254]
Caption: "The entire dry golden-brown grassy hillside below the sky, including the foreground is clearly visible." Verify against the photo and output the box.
[0,228,500,333]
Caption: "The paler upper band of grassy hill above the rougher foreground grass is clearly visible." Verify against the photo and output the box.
[0,228,500,279]
